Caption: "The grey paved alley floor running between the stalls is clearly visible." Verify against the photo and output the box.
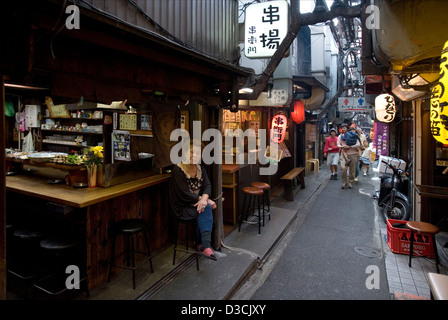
[247,164,448,300]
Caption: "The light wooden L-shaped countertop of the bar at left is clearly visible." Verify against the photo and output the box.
[6,174,171,208]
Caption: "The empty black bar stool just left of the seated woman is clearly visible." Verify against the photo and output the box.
[107,219,154,289]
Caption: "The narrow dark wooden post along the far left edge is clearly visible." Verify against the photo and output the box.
[0,74,6,300]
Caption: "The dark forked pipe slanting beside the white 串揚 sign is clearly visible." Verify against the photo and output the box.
[238,0,361,100]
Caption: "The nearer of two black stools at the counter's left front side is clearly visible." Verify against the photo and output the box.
[34,236,90,297]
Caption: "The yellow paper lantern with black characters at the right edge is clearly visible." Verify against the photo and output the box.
[430,41,448,144]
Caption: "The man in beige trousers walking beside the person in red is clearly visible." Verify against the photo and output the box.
[338,123,361,189]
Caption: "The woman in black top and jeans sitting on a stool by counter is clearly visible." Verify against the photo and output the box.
[169,142,216,260]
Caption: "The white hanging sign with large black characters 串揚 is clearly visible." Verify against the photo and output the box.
[244,1,289,59]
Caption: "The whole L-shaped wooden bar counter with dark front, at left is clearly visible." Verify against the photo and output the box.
[6,174,171,289]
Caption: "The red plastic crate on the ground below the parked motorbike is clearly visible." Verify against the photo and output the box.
[387,219,435,258]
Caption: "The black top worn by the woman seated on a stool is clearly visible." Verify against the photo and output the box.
[169,165,212,220]
